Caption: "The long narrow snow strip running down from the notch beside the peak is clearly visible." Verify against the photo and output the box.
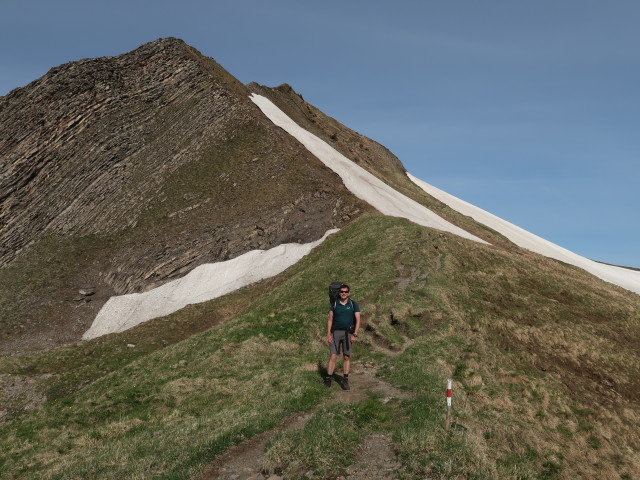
[251,93,487,243]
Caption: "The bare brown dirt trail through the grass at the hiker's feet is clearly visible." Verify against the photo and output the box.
[201,362,408,480]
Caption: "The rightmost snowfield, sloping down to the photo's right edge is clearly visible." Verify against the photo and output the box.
[407,173,640,293]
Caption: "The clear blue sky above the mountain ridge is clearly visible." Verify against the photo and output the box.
[0,0,640,267]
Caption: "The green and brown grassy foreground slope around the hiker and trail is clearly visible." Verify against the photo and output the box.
[0,216,640,478]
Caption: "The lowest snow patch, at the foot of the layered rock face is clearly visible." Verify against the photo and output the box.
[82,229,338,340]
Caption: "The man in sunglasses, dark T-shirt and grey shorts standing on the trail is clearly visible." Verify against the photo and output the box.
[324,284,360,390]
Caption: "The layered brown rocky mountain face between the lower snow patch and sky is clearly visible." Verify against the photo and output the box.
[0,39,368,351]
